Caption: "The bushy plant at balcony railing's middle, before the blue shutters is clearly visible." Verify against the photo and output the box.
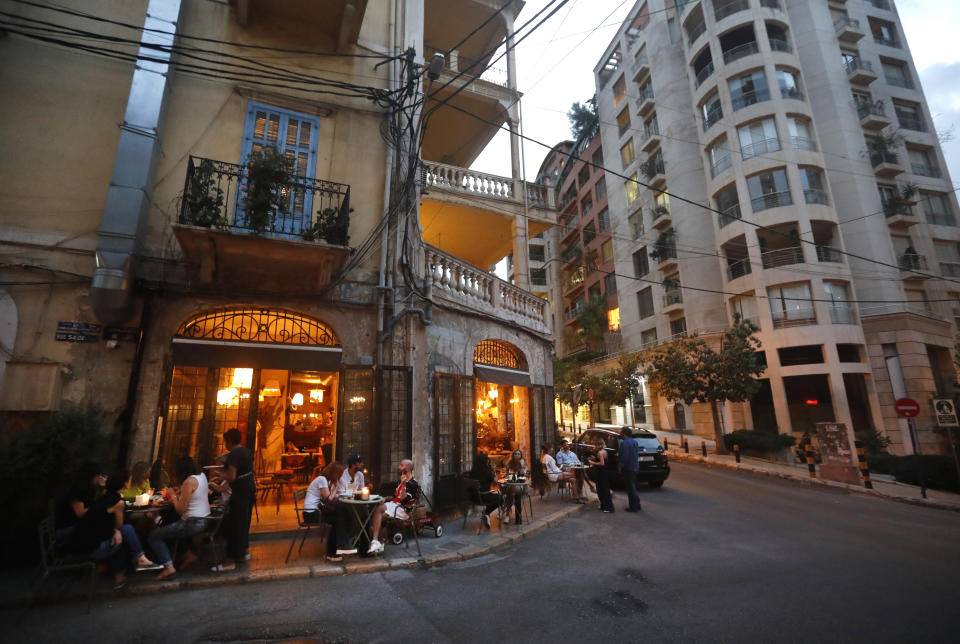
[243,147,293,235]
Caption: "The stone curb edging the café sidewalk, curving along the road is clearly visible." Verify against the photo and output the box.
[0,504,587,608]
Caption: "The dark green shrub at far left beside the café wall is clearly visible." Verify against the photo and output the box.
[0,408,116,565]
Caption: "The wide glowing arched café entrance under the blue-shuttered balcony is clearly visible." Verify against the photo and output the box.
[157,307,344,500]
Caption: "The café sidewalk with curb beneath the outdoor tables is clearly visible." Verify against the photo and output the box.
[0,491,593,608]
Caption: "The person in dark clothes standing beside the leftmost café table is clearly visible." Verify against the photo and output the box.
[214,427,256,572]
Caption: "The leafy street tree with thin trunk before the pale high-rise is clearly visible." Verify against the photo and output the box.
[640,314,765,453]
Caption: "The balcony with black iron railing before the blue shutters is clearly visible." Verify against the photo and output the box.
[173,156,350,292]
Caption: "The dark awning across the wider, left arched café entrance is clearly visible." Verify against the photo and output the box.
[173,338,343,371]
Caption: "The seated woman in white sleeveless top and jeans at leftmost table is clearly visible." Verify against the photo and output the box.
[148,456,210,579]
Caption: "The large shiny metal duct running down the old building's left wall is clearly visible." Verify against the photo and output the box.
[90,0,181,324]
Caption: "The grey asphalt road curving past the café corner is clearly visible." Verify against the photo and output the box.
[7,464,960,644]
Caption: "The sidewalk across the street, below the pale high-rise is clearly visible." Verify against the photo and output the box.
[568,424,960,512]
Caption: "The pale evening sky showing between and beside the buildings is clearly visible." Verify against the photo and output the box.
[473,0,960,185]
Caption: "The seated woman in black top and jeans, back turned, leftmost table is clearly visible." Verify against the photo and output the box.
[67,470,160,588]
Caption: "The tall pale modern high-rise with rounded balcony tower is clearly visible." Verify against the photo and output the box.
[595,0,960,454]
